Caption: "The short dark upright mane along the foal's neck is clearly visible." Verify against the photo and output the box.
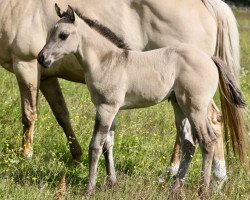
[74,9,130,51]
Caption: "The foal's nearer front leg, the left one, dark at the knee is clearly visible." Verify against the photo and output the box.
[87,104,118,195]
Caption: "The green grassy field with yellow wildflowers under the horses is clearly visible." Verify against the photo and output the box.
[0,11,250,200]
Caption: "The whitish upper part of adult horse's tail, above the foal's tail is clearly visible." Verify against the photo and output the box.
[203,0,240,78]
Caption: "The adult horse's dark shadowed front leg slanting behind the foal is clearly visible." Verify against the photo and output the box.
[40,78,82,162]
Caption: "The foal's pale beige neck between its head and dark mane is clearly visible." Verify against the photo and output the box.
[77,19,123,73]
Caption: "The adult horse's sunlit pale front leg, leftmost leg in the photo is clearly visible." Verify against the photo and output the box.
[13,58,40,158]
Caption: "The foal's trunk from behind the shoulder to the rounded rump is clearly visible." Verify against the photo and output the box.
[120,44,218,107]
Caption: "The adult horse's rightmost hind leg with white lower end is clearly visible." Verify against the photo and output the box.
[208,101,227,191]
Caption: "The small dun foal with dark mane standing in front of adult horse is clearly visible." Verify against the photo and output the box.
[38,5,244,193]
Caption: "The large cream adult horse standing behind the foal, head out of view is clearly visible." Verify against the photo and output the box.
[0,0,239,184]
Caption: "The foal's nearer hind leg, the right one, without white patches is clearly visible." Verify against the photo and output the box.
[174,93,217,195]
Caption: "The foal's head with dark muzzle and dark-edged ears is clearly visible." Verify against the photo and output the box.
[37,4,79,68]
